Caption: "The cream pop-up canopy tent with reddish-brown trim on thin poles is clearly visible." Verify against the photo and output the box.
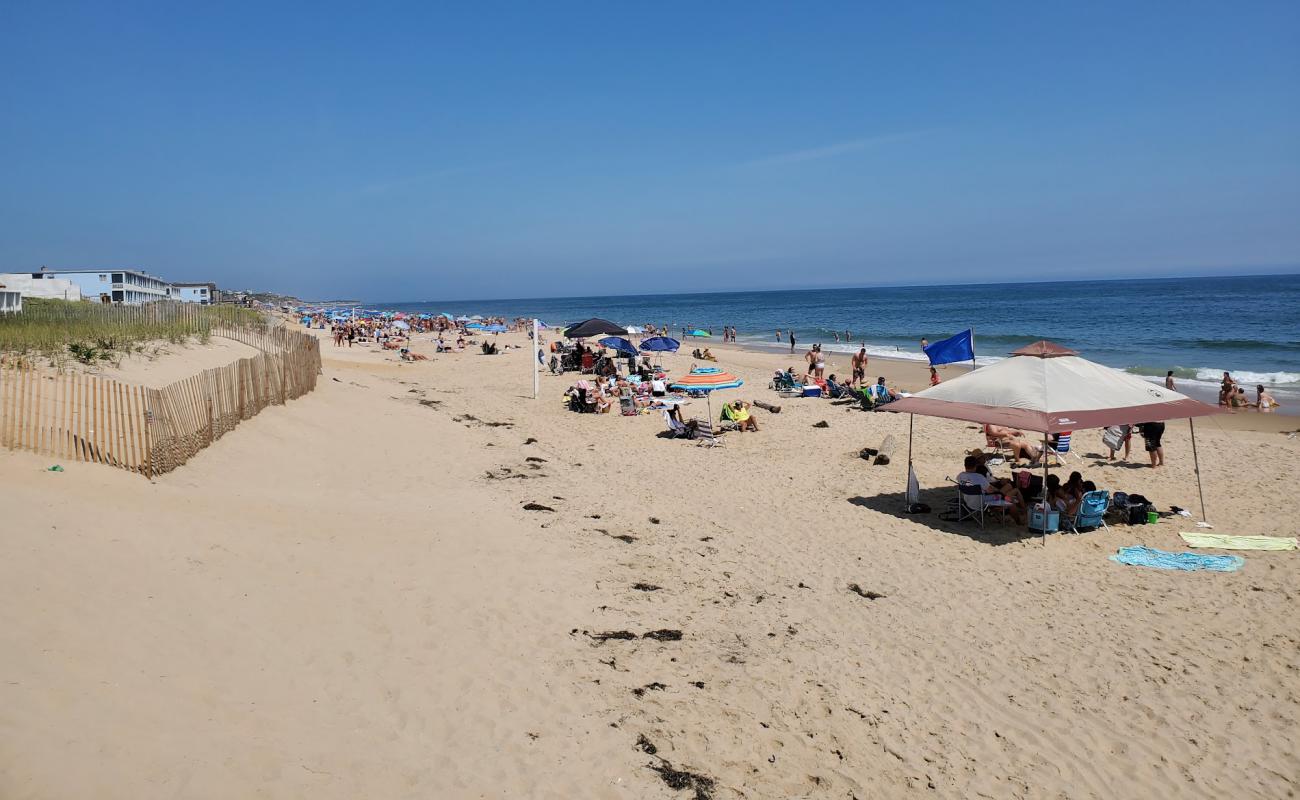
[884,341,1221,518]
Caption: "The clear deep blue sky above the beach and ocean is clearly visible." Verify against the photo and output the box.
[0,1,1300,300]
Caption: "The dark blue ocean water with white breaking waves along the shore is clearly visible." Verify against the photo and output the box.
[378,274,1300,405]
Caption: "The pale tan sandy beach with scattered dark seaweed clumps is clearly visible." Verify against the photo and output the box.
[0,334,1300,800]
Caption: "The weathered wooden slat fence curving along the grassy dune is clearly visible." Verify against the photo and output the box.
[0,327,321,477]
